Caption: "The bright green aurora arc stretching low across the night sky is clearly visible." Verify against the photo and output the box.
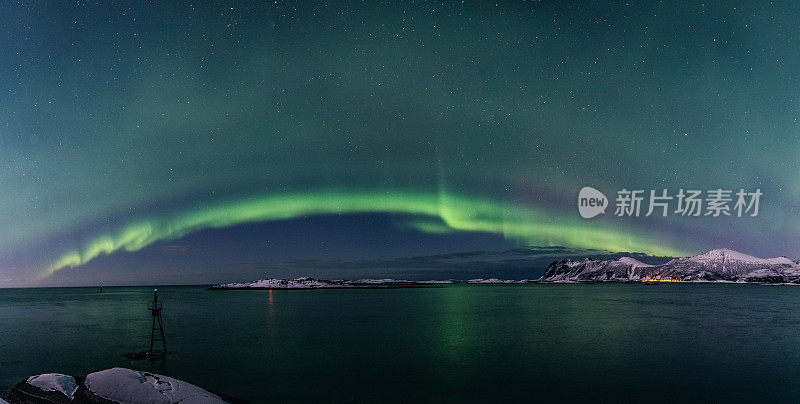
[47,191,687,276]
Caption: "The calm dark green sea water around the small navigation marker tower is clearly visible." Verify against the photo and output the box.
[0,284,800,402]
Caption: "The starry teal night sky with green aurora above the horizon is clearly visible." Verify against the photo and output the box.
[0,1,800,286]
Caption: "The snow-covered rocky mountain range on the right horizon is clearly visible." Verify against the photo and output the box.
[540,248,800,283]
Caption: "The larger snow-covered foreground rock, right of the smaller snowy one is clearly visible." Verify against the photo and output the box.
[78,368,225,403]
